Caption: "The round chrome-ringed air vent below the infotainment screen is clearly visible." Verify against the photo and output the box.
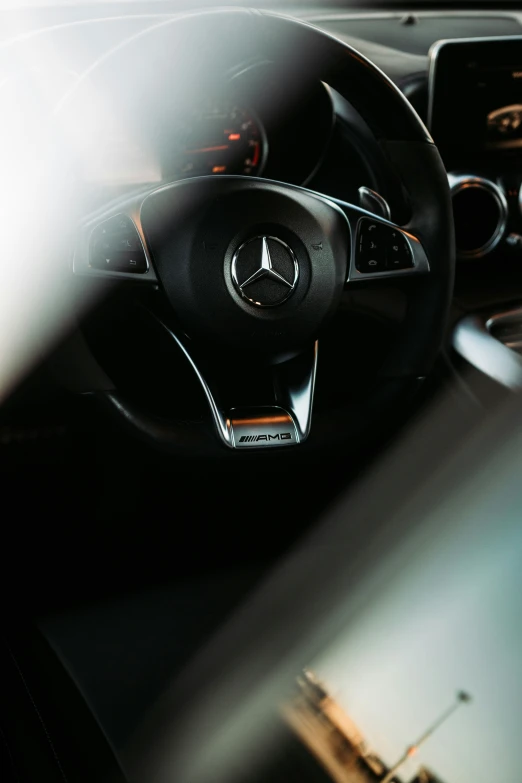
[448,174,508,258]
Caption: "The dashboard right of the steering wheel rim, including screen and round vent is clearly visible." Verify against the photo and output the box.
[290,5,522,312]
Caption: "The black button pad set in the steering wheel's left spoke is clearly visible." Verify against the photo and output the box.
[89,215,147,274]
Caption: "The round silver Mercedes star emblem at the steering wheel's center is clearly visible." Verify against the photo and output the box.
[231,236,299,307]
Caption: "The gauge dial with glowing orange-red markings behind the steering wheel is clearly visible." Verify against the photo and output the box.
[174,106,266,178]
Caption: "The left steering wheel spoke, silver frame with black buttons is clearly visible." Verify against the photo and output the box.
[72,194,158,284]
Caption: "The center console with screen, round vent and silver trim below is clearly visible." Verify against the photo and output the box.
[428,36,522,391]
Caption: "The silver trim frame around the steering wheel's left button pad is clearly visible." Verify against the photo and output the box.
[72,193,158,284]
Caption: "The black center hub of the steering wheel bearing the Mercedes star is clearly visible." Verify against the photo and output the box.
[141,176,350,355]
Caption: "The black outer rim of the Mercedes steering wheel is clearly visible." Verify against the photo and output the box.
[46,9,454,455]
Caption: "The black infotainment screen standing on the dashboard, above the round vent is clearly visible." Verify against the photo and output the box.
[428,36,522,147]
